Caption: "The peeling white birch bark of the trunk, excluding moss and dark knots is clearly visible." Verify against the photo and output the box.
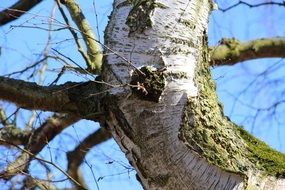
[103,0,284,190]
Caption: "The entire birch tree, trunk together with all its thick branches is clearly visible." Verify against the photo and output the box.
[0,0,285,190]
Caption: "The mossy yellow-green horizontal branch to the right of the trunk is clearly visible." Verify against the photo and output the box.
[210,38,285,66]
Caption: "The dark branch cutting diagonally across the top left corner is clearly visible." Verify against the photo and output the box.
[0,0,42,26]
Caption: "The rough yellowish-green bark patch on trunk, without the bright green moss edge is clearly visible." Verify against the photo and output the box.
[181,54,248,173]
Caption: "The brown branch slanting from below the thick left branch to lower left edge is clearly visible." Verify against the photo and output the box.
[0,114,80,179]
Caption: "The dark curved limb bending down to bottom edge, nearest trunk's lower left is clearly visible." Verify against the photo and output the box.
[67,128,111,188]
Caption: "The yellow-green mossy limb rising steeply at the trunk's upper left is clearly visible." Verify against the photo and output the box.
[56,0,102,74]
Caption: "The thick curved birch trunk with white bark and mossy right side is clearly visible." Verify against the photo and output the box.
[102,0,285,190]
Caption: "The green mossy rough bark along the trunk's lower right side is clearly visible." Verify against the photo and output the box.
[180,35,285,177]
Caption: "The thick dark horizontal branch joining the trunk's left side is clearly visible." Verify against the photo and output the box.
[0,76,102,116]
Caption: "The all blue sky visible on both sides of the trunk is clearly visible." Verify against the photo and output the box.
[0,0,285,190]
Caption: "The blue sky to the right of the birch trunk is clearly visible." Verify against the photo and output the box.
[209,0,285,152]
